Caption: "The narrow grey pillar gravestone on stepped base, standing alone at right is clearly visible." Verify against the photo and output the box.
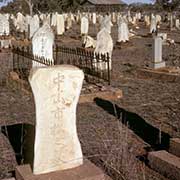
[153,36,166,69]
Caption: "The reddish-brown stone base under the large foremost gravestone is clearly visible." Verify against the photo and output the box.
[15,159,111,180]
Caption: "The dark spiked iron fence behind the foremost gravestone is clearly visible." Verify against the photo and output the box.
[12,46,110,85]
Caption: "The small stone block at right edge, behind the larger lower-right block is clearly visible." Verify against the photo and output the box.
[169,138,180,158]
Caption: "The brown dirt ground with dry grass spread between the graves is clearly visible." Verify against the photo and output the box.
[0,20,180,180]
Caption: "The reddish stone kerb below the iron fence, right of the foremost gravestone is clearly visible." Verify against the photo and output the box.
[79,88,123,103]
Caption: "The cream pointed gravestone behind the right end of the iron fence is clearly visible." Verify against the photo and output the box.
[94,28,113,70]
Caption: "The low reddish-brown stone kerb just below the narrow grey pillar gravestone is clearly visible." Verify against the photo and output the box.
[137,69,180,83]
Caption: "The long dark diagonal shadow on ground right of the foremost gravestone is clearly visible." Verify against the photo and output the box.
[94,98,171,150]
